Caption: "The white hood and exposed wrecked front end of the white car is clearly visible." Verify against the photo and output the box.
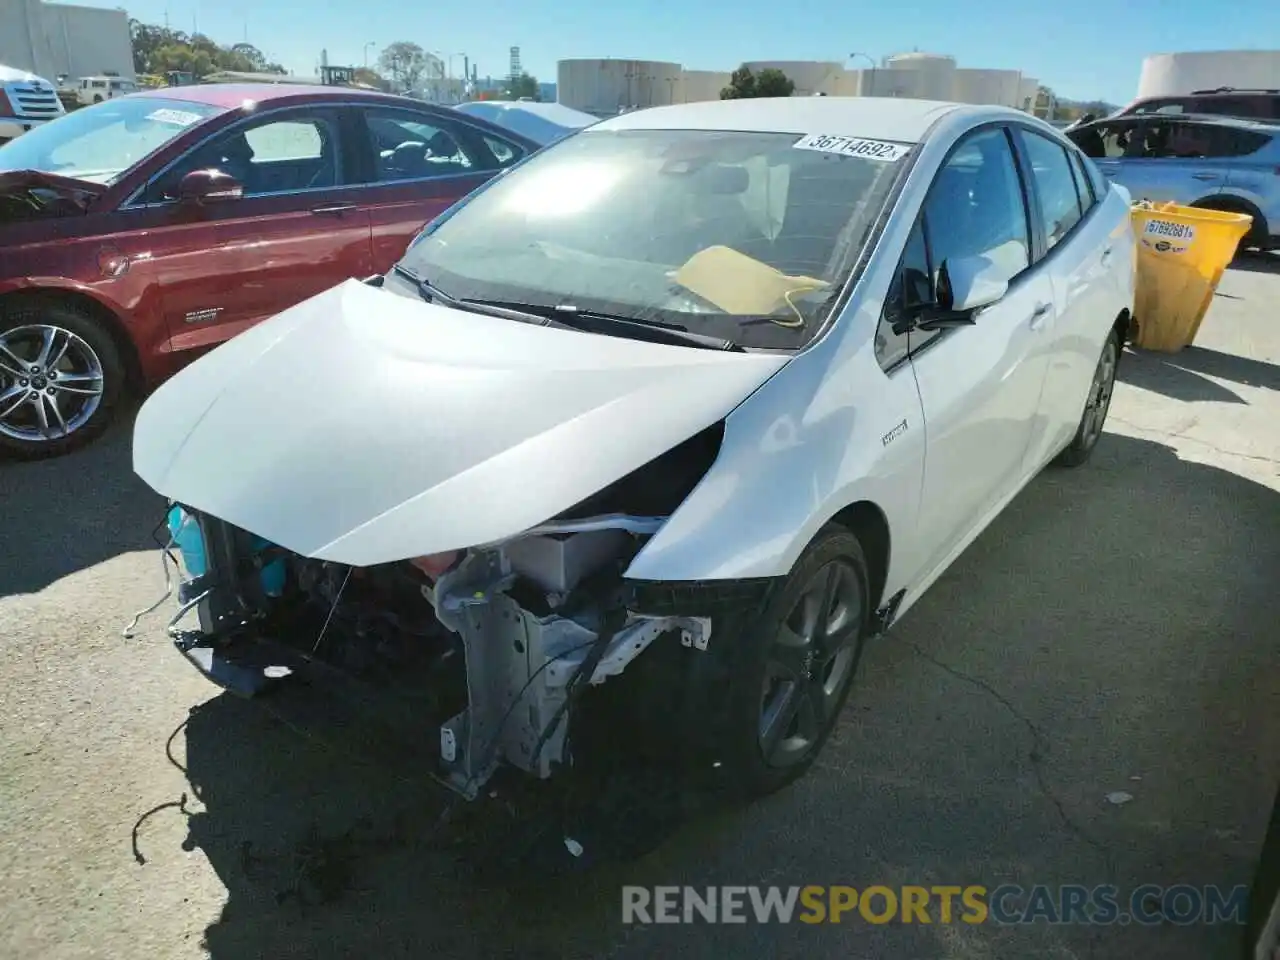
[133,282,787,796]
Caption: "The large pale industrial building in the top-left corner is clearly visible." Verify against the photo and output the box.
[0,0,134,82]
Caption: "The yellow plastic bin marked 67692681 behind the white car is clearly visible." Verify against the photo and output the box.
[1132,201,1253,353]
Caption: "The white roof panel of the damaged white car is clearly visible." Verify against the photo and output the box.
[593,97,993,143]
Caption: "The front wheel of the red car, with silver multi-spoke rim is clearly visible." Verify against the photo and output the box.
[0,300,125,460]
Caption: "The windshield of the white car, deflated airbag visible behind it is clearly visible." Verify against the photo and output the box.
[402,129,908,348]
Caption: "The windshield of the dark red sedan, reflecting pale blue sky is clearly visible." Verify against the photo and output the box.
[0,97,223,183]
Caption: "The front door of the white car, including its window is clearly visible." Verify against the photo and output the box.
[908,127,1055,575]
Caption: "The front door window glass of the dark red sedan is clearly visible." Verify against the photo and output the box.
[147,111,344,202]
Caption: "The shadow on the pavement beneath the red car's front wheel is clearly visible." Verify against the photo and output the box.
[0,407,164,596]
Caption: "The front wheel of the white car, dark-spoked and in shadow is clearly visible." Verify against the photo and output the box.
[704,526,870,799]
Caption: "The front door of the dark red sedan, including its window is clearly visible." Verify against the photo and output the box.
[134,108,372,362]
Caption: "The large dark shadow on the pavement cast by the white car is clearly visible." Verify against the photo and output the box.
[167,434,1280,960]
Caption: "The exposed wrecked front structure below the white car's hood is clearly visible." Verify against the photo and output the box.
[148,425,719,799]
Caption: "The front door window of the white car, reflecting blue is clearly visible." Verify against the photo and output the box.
[924,127,1030,283]
